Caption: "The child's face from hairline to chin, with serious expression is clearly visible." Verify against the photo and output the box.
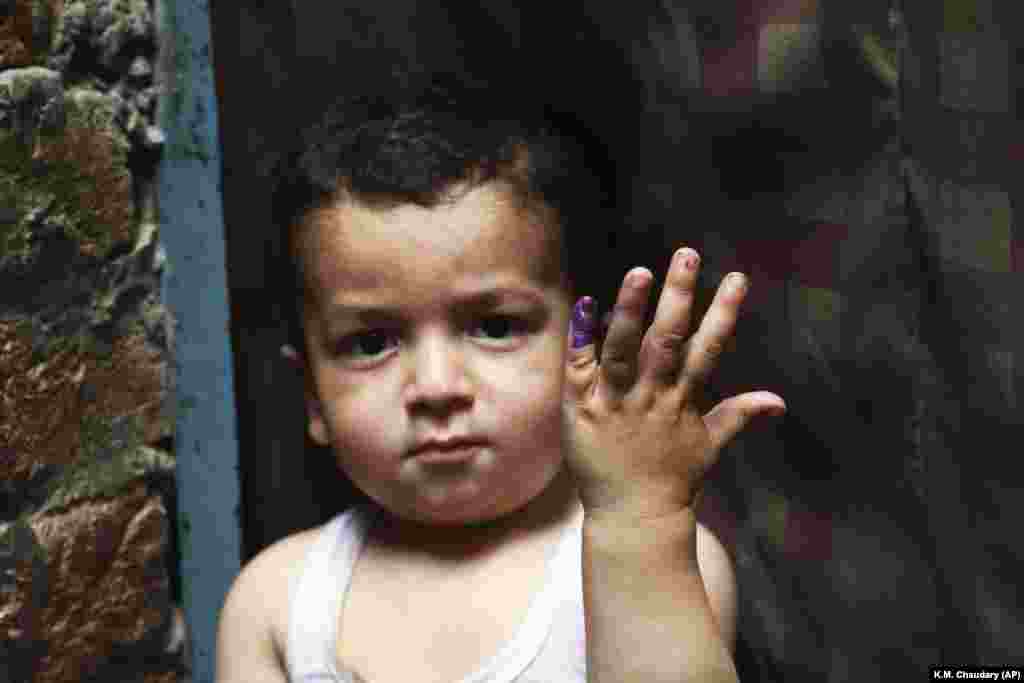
[298,182,570,523]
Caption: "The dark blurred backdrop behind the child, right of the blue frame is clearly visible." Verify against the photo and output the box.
[203,0,1024,681]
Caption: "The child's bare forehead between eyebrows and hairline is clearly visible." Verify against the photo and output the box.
[304,183,558,290]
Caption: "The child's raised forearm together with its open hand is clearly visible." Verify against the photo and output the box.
[565,250,784,683]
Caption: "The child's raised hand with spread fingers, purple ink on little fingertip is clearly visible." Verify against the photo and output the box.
[564,249,785,520]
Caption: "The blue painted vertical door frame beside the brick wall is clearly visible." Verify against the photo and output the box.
[157,0,242,683]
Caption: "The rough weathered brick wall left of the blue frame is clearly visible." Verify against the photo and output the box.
[0,0,187,683]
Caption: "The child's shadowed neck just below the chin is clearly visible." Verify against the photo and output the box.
[372,468,580,565]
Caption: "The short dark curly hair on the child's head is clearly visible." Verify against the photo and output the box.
[268,72,625,362]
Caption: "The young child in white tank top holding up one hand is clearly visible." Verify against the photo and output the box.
[217,72,784,683]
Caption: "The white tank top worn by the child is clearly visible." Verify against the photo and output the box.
[285,504,587,683]
